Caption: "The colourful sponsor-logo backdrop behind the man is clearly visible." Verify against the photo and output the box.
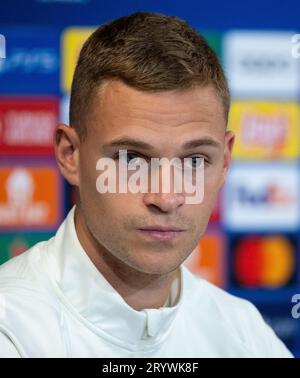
[0,0,300,356]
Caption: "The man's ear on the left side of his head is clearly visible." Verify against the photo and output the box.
[54,124,80,186]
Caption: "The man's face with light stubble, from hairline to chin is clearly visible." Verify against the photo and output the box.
[73,81,233,274]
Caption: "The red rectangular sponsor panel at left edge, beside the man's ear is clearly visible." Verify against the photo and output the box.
[0,97,59,156]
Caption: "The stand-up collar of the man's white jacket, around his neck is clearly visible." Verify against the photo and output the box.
[48,206,189,344]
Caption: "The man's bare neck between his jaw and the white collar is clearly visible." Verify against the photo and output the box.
[75,205,179,311]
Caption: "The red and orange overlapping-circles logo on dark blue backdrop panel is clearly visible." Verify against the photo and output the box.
[233,236,295,288]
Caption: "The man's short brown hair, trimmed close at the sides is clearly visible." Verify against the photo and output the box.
[70,12,230,139]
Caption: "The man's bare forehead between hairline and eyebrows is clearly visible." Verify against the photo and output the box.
[86,80,226,143]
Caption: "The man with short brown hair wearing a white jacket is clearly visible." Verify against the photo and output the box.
[0,13,291,357]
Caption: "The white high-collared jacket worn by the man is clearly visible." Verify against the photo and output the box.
[0,207,291,358]
